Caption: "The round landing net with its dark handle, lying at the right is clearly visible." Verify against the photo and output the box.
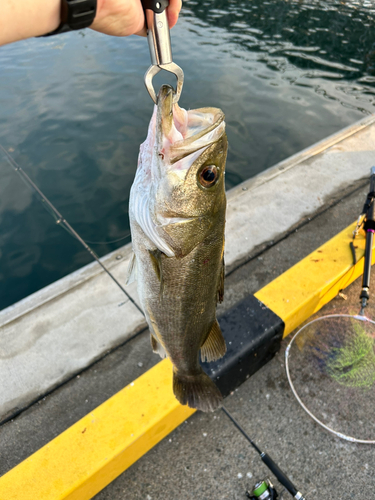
[285,167,375,444]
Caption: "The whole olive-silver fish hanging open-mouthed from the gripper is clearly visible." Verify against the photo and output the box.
[127,85,228,411]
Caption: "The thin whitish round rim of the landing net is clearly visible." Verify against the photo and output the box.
[285,314,375,444]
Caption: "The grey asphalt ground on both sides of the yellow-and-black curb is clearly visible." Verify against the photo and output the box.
[0,180,375,500]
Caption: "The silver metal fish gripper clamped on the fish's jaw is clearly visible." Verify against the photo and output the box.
[142,0,184,104]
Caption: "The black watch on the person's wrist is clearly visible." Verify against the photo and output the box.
[42,0,96,36]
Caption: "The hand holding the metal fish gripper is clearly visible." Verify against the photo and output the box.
[90,0,182,36]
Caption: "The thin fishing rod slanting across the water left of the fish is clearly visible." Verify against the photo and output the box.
[0,144,144,316]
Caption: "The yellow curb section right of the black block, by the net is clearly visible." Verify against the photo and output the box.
[255,224,368,337]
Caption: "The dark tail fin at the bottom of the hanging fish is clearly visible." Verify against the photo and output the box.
[173,369,223,411]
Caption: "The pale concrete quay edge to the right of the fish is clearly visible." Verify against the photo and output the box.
[225,116,375,272]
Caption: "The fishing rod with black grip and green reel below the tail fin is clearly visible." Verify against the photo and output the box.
[221,406,305,500]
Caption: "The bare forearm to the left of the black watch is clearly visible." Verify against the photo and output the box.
[0,0,61,45]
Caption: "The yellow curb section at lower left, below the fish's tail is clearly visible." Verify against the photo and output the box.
[0,360,195,500]
